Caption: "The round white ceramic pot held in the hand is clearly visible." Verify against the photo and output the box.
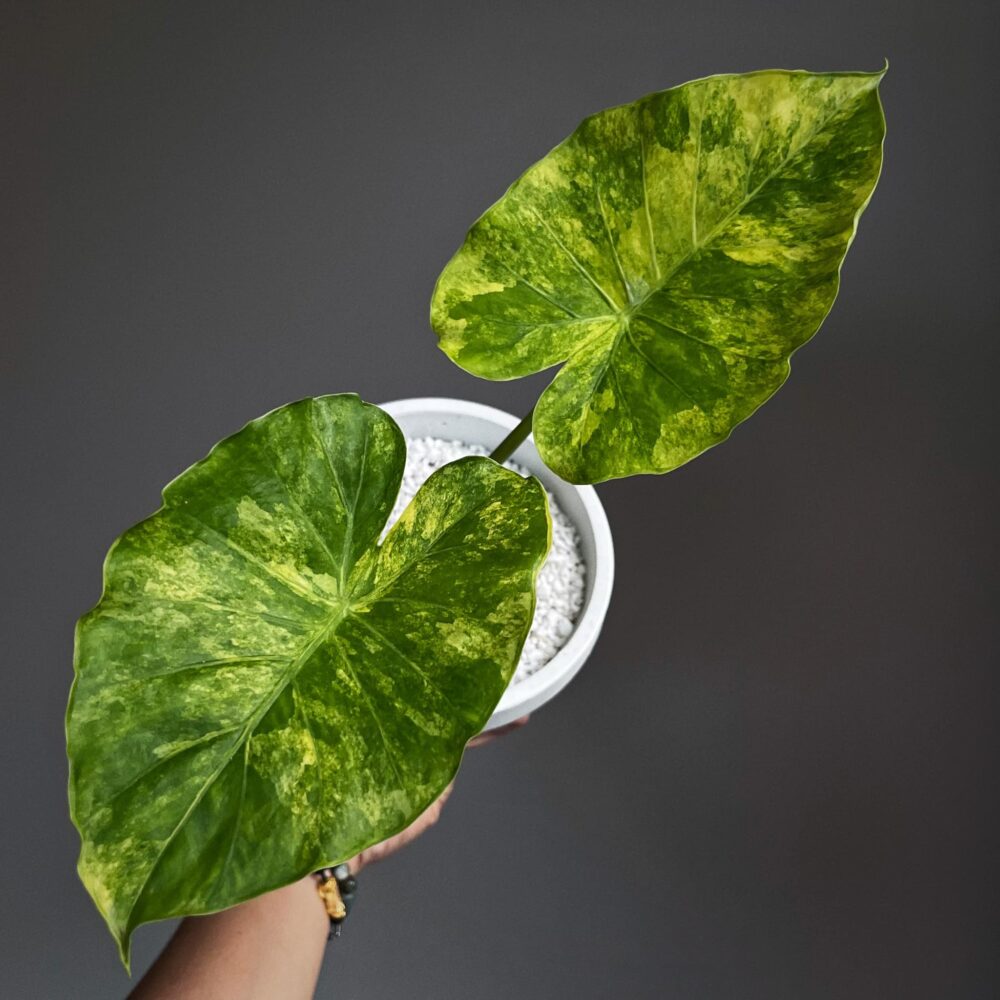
[381,398,615,729]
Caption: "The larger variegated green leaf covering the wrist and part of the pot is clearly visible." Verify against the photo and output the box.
[67,395,549,962]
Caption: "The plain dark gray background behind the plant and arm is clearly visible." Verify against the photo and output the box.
[0,0,998,1000]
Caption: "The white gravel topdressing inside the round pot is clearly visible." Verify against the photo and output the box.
[389,437,587,684]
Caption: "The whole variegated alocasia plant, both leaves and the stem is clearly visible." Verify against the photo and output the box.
[67,64,885,964]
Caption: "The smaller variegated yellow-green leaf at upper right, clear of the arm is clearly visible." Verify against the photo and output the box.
[431,70,885,482]
